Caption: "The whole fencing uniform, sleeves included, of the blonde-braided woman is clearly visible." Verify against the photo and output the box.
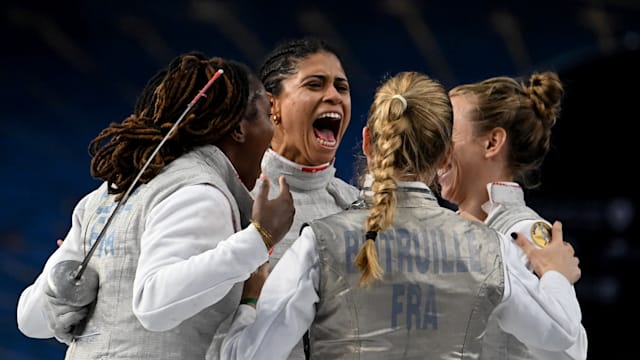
[222,182,580,359]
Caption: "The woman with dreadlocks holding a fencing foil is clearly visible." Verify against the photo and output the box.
[17,53,294,360]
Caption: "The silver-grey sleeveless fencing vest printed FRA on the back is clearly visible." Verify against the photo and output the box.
[310,184,504,359]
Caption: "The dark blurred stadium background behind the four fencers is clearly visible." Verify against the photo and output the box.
[0,0,640,360]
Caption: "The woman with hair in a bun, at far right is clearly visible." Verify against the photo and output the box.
[438,71,587,360]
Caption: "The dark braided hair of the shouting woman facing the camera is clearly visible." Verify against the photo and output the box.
[259,37,346,96]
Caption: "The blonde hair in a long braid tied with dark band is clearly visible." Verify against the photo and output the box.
[355,72,453,287]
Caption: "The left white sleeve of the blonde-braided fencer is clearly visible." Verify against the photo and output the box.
[220,226,320,360]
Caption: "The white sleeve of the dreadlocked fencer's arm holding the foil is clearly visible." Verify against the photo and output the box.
[17,196,87,339]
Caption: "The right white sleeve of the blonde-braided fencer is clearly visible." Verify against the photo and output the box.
[495,234,582,351]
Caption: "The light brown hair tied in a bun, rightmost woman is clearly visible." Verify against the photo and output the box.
[449,71,564,189]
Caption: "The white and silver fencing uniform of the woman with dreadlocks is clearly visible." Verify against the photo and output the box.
[18,145,268,360]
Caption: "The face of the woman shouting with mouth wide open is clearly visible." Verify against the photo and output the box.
[271,51,351,166]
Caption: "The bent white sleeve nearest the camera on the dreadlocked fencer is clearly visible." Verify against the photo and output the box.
[133,184,268,331]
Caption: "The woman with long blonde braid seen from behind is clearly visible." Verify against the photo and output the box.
[221,72,580,360]
